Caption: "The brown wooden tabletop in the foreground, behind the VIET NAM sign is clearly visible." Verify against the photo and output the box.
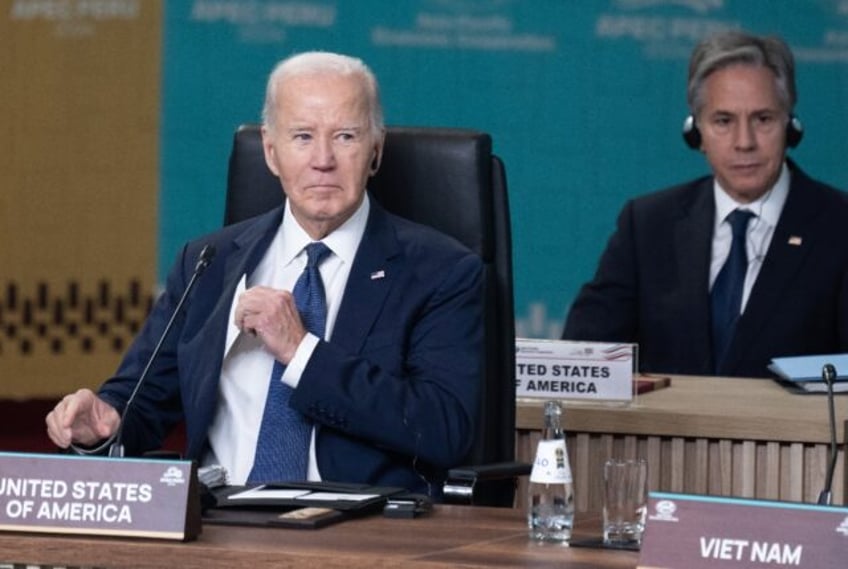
[0,506,639,569]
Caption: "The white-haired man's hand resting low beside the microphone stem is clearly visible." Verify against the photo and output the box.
[45,389,121,448]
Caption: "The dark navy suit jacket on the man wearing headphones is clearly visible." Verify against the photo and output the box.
[563,162,848,377]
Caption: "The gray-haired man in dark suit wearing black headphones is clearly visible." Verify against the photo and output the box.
[562,31,848,377]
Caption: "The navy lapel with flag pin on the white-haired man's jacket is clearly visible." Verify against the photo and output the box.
[331,200,403,353]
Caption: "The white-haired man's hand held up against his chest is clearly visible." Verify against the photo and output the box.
[235,286,306,364]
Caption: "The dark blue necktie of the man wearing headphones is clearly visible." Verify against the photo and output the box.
[710,209,754,372]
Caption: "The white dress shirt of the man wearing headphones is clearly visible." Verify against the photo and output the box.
[710,163,790,313]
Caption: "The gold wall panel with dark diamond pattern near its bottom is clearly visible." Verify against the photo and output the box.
[0,0,162,398]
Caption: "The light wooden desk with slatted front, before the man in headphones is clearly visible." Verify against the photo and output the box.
[516,376,848,512]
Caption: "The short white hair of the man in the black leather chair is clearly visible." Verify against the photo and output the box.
[262,51,384,136]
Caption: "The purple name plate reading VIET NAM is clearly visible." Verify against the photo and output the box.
[638,492,848,569]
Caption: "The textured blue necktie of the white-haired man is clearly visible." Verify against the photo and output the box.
[247,241,330,483]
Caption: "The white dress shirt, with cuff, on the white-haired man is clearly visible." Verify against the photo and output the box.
[203,194,370,484]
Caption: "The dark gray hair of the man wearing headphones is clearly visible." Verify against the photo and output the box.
[686,30,797,116]
